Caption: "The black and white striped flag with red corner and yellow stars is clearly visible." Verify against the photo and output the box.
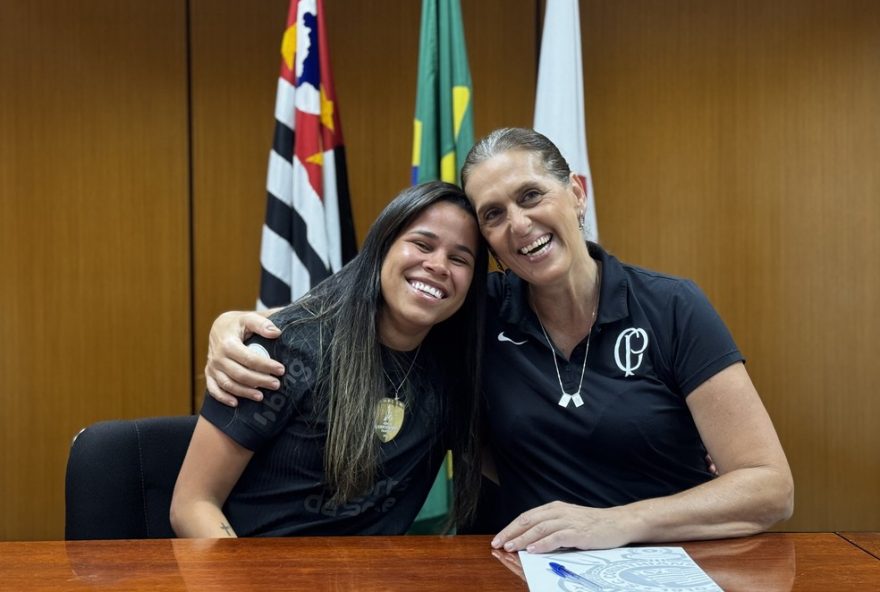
[257,0,357,309]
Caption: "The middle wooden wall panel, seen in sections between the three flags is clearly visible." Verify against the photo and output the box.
[191,0,536,408]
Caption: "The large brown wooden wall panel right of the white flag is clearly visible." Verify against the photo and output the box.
[581,0,880,530]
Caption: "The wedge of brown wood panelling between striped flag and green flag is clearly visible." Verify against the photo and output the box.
[324,0,421,244]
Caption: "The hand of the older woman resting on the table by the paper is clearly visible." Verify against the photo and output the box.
[492,501,635,553]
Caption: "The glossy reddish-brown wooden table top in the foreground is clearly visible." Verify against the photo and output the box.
[0,533,880,592]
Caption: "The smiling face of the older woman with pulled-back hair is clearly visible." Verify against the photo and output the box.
[465,150,586,286]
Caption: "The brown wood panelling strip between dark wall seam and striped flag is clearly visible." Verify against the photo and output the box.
[190,0,289,404]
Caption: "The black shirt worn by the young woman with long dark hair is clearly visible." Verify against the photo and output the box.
[201,305,448,536]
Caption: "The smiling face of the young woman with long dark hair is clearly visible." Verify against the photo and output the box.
[379,202,479,350]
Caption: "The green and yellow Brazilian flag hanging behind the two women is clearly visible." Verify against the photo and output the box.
[410,0,474,534]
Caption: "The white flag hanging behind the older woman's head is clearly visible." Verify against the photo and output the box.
[534,0,599,241]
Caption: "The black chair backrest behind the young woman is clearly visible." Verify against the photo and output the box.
[64,415,197,540]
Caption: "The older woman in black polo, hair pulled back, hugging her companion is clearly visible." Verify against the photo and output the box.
[206,128,794,552]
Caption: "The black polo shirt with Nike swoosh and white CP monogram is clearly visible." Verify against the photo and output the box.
[483,243,743,524]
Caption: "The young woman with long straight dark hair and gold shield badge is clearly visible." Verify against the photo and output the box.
[171,182,487,537]
